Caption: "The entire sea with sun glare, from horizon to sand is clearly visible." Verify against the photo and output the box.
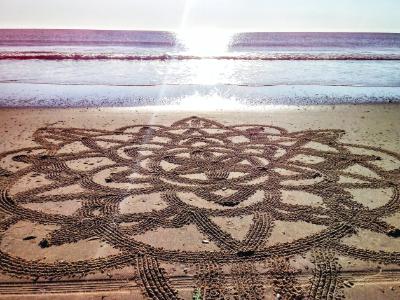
[0,29,400,109]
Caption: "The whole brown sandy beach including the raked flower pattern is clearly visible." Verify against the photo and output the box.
[0,104,400,299]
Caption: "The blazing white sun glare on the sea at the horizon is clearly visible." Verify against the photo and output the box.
[177,29,232,57]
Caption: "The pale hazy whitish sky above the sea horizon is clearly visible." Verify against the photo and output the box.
[0,0,400,32]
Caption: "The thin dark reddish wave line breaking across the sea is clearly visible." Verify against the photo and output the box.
[0,51,400,61]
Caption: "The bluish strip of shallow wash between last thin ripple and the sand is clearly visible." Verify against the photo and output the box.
[0,83,400,110]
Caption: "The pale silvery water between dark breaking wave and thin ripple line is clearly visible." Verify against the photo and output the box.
[0,59,400,87]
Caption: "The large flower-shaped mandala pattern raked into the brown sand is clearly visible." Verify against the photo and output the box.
[0,117,400,299]
